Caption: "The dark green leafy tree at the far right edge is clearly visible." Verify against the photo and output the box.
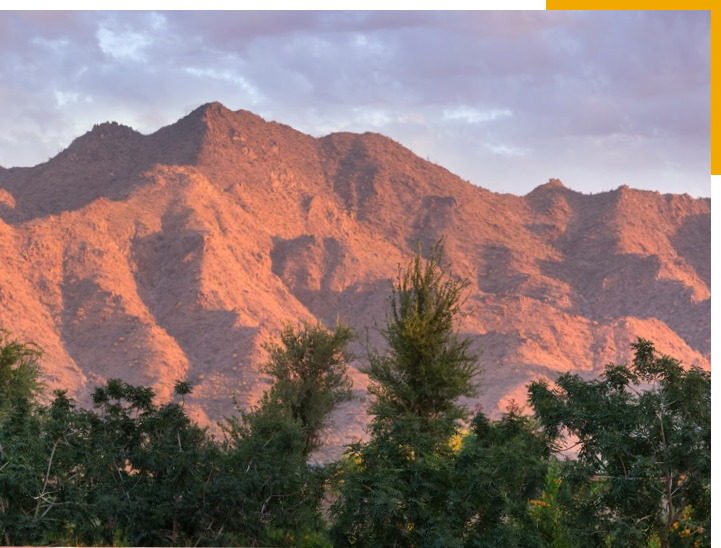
[529,339,711,548]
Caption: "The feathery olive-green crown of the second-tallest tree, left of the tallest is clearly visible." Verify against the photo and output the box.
[261,323,353,454]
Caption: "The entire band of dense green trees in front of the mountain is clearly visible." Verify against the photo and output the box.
[0,244,710,548]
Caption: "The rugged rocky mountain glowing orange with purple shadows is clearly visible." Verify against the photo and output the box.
[0,103,711,458]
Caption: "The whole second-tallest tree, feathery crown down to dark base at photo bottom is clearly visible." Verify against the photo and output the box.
[217,323,353,546]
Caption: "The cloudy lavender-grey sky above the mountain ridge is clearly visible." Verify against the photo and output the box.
[0,11,711,196]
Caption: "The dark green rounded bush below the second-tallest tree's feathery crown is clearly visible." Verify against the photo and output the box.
[219,402,326,546]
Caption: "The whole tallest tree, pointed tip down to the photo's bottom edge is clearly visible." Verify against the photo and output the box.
[330,241,478,546]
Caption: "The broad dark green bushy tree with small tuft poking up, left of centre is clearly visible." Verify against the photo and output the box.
[46,379,222,546]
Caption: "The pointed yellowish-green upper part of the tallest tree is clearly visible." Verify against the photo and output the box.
[364,241,479,431]
